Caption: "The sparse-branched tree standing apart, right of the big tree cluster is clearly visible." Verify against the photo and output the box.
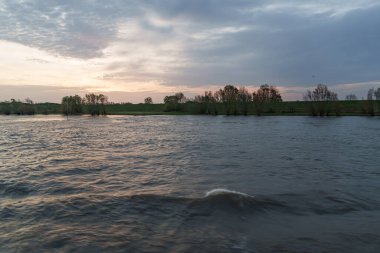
[304,84,340,116]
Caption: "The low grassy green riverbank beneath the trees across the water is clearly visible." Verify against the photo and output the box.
[0,100,380,116]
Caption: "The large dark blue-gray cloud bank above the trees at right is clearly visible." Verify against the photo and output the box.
[162,1,380,85]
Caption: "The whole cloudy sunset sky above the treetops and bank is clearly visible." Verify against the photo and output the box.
[0,0,380,103]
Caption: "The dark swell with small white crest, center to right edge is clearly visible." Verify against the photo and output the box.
[115,188,380,215]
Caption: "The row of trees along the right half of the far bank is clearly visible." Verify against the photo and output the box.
[160,84,380,116]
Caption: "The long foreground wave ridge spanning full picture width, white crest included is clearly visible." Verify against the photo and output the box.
[0,189,380,222]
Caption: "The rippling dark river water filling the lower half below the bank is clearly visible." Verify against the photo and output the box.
[0,116,380,252]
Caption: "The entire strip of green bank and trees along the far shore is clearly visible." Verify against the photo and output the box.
[0,84,380,116]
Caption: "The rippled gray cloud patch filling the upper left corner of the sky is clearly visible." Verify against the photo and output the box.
[0,0,138,58]
